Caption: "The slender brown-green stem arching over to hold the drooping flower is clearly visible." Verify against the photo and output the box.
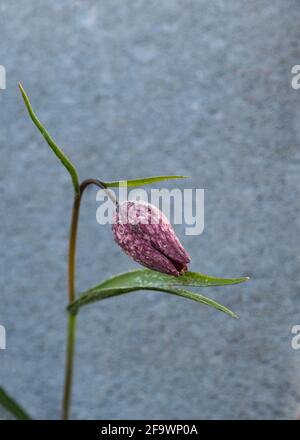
[62,179,118,420]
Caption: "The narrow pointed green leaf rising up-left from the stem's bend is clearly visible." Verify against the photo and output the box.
[19,83,79,194]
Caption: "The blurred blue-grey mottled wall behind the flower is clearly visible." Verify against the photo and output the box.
[0,0,300,419]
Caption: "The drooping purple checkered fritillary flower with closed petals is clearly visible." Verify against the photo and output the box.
[112,201,190,276]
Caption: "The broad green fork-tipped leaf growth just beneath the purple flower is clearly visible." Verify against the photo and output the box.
[68,269,248,318]
